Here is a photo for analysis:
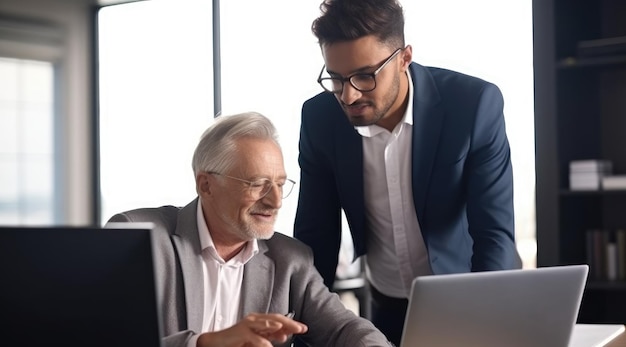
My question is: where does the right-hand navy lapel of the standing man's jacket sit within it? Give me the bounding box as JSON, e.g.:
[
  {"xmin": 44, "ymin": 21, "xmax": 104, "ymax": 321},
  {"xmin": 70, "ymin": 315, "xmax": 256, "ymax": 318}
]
[{"xmin": 410, "ymin": 63, "xmax": 444, "ymax": 220}]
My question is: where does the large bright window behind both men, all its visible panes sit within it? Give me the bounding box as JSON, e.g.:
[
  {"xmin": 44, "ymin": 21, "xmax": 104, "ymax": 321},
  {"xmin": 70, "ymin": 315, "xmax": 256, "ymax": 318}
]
[{"xmin": 99, "ymin": 0, "xmax": 536, "ymax": 267}]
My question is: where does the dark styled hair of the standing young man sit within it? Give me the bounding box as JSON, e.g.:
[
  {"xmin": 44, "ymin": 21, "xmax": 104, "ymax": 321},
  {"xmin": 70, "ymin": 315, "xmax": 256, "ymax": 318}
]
[{"xmin": 311, "ymin": 0, "xmax": 404, "ymax": 48}]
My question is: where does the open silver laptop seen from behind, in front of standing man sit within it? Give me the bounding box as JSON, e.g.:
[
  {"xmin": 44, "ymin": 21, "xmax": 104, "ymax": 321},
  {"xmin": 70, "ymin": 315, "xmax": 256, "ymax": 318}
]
[{"xmin": 400, "ymin": 264, "xmax": 589, "ymax": 347}]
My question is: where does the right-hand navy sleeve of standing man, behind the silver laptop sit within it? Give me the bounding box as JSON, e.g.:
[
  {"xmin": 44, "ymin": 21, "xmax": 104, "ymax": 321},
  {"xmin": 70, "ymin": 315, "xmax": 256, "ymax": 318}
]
[{"xmin": 466, "ymin": 84, "xmax": 521, "ymax": 271}]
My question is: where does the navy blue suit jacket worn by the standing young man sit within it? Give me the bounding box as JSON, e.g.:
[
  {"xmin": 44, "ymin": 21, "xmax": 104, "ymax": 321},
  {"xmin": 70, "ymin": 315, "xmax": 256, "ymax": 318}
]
[{"xmin": 294, "ymin": 63, "xmax": 521, "ymax": 287}]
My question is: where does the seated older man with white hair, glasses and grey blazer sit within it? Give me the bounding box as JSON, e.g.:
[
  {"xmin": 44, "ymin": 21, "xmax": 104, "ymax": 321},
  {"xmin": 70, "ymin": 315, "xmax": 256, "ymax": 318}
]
[{"xmin": 109, "ymin": 113, "xmax": 389, "ymax": 347}]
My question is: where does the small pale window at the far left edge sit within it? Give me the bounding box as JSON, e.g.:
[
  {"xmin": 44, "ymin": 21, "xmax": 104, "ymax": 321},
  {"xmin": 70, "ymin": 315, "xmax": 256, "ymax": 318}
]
[{"xmin": 0, "ymin": 58, "xmax": 56, "ymax": 225}]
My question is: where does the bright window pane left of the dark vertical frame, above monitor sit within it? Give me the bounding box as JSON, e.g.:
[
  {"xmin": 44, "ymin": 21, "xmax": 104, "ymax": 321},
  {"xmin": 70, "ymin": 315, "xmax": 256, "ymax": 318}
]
[{"xmin": 98, "ymin": 0, "xmax": 213, "ymax": 223}]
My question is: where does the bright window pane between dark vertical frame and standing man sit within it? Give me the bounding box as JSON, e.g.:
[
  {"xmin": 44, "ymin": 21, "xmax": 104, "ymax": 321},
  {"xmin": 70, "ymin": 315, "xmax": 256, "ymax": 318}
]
[{"xmin": 220, "ymin": 0, "xmax": 324, "ymax": 235}]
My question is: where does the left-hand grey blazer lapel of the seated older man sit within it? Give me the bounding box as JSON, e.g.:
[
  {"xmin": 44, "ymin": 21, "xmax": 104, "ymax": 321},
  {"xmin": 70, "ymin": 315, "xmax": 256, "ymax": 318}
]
[{"xmin": 172, "ymin": 199, "xmax": 204, "ymax": 331}]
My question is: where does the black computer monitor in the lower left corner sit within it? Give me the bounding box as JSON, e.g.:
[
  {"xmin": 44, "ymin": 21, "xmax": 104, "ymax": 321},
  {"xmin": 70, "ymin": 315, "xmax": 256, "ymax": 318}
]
[{"xmin": 0, "ymin": 224, "xmax": 161, "ymax": 347}]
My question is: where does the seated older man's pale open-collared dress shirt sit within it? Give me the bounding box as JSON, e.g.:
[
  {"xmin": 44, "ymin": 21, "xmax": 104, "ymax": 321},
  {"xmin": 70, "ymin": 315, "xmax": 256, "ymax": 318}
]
[{"xmin": 188, "ymin": 200, "xmax": 259, "ymax": 347}]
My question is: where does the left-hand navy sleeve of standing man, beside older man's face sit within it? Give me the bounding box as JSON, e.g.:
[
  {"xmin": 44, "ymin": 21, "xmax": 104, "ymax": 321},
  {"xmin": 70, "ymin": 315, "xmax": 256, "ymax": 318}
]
[{"xmin": 294, "ymin": 97, "xmax": 341, "ymax": 288}]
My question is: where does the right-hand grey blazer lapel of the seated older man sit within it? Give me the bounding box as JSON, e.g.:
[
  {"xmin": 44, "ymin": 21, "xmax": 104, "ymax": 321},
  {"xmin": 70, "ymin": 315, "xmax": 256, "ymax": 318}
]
[{"xmin": 241, "ymin": 240, "xmax": 275, "ymax": 316}]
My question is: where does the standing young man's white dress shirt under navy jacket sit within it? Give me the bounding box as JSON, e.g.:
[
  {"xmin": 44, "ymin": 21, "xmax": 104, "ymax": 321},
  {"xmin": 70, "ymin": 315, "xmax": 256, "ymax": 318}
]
[{"xmin": 355, "ymin": 73, "xmax": 432, "ymax": 298}]
